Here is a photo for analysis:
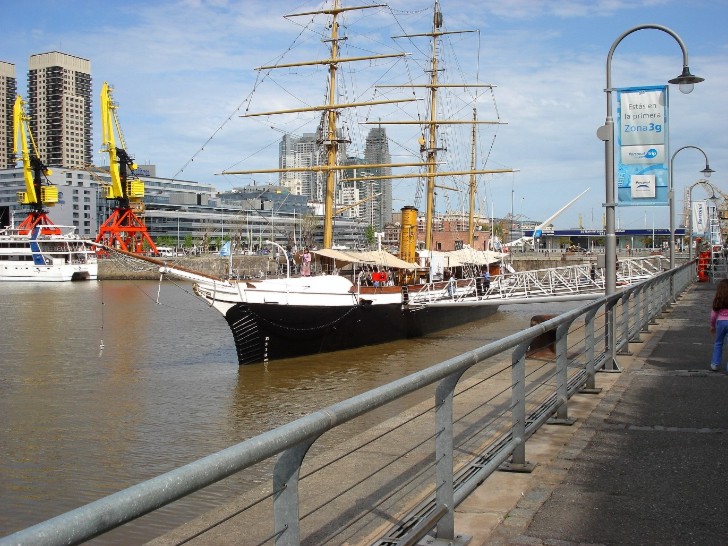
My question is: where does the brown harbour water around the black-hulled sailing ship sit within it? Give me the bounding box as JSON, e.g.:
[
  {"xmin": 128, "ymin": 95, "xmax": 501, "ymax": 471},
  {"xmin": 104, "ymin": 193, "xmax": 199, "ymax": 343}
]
[{"xmin": 0, "ymin": 281, "xmax": 570, "ymax": 544}]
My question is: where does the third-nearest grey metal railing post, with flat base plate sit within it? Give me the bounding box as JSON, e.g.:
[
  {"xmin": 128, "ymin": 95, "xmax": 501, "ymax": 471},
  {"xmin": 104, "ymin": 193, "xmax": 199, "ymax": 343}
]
[{"xmin": 501, "ymin": 339, "xmax": 535, "ymax": 472}]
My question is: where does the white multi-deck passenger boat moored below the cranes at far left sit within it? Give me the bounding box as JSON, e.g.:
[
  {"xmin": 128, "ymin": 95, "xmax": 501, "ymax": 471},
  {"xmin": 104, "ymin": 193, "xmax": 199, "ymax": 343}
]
[{"xmin": 0, "ymin": 224, "xmax": 98, "ymax": 282}]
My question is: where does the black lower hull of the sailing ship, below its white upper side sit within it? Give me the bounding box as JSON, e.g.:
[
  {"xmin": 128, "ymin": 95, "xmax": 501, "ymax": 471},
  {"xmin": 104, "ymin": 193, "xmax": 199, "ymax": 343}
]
[{"xmin": 225, "ymin": 302, "xmax": 498, "ymax": 365}]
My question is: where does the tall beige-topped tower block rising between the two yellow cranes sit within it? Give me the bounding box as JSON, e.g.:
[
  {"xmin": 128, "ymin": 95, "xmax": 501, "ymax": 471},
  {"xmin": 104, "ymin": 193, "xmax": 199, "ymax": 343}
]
[{"xmin": 28, "ymin": 51, "xmax": 93, "ymax": 168}]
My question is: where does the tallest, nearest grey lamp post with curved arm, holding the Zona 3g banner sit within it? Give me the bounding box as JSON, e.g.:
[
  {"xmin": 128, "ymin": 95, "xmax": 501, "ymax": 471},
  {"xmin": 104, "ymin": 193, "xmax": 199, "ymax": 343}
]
[{"xmin": 597, "ymin": 24, "xmax": 704, "ymax": 369}]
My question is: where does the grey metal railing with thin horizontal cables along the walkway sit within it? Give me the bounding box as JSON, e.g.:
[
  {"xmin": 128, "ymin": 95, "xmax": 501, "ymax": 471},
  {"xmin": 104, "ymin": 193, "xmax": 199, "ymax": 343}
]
[{"xmin": 0, "ymin": 262, "xmax": 696, "ymax": 546}]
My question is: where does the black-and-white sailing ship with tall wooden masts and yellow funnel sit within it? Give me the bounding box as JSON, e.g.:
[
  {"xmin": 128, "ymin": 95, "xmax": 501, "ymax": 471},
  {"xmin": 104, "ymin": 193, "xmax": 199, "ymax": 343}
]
[{"xmin": 161, "ymin": 0, "xmax": 512, "ymax": 364}]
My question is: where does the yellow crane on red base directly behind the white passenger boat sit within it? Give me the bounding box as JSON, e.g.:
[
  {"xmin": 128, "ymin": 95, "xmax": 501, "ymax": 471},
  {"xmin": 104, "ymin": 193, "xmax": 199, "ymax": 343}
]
[{"xmin": 13, "ymin": 95, "xmax": 60, "ymax": 233}]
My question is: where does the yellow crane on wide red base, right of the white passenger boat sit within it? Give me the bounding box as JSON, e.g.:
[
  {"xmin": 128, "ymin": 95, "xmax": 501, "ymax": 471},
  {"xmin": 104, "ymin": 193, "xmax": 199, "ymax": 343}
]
[{"xmin": 96, "ymin": 82, "xmax": 157, "ymax": 254}]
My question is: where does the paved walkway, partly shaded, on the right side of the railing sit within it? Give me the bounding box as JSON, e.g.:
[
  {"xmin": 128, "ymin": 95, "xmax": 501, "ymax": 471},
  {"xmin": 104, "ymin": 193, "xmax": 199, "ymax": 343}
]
[{"xmin": 455, "ymin": 283, "xmax": 728, "ymax": 546}]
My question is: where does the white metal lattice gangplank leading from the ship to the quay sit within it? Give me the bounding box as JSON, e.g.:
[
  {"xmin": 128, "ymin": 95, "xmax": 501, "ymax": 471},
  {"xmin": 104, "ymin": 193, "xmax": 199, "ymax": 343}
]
[{"xmin": 408, "ymin": 255, "xmax": 669, "ymax": 307}]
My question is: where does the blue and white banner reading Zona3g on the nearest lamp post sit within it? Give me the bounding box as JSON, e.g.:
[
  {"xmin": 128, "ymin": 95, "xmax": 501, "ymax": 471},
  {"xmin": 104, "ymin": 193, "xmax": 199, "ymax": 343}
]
[{"xmin": 616, "ymin": 86, "xmax": 669, "ymax": 206}]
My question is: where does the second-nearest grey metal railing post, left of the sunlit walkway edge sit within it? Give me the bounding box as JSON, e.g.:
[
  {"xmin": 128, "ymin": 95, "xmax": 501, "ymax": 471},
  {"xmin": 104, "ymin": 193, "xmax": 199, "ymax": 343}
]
[{"xmin": 435, "ymin": 372, "xmax": 464, "ymax": 540}]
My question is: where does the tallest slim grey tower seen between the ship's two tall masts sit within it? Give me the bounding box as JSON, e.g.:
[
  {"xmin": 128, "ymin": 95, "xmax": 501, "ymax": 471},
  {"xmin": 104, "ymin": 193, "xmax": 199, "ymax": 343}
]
[{"xmin": 359, "ymin": 127, "xmax": 392, "ymax": 231}]
